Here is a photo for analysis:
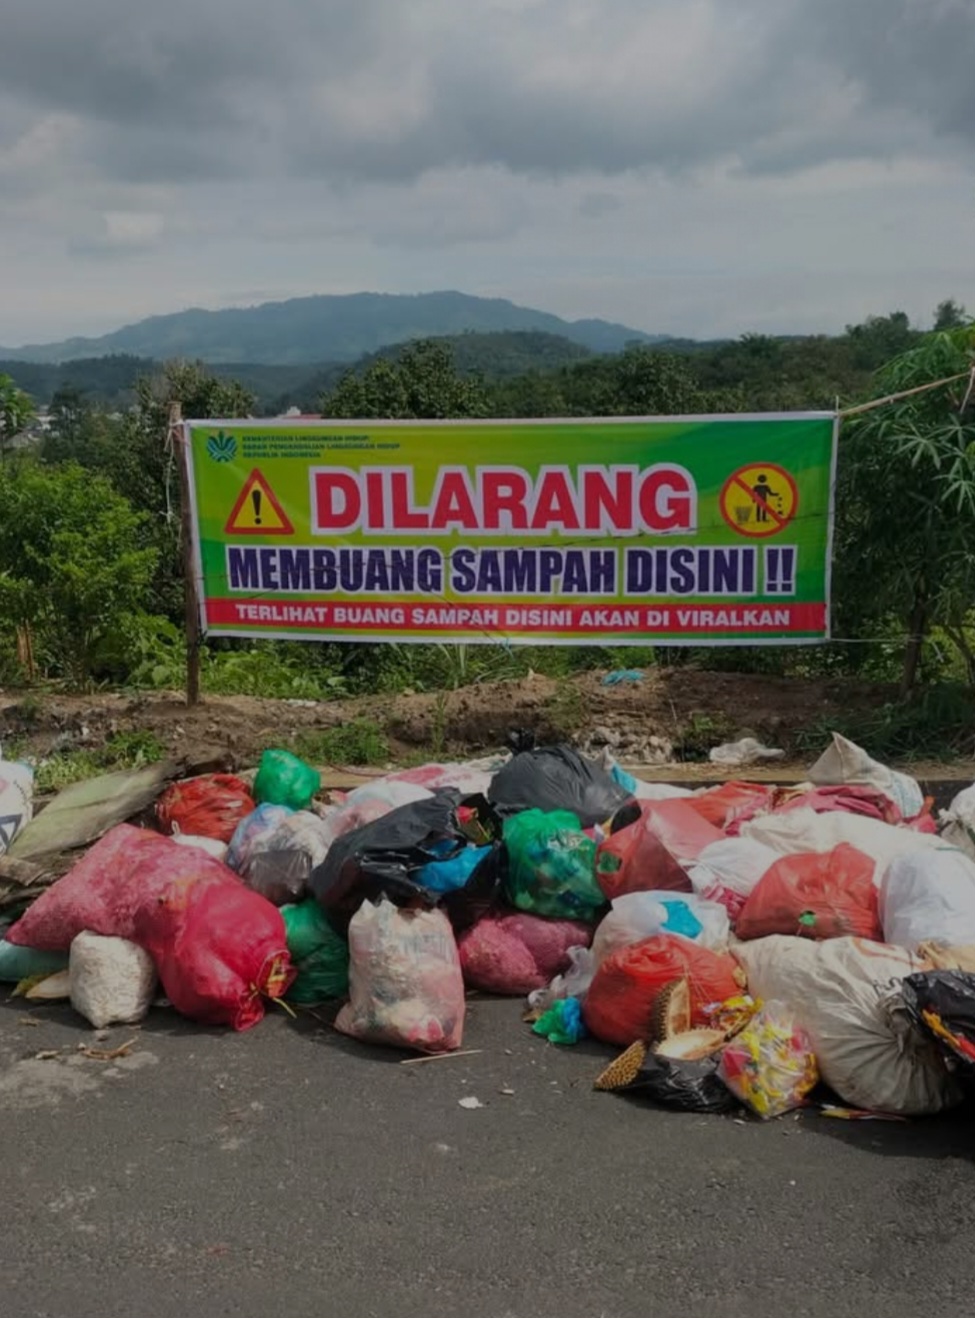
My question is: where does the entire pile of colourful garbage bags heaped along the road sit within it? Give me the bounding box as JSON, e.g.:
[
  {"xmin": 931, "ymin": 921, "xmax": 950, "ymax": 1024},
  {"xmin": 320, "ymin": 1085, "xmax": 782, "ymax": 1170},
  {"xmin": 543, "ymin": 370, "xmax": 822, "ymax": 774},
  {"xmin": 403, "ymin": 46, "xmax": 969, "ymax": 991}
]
[{"xmin": 0, "ymin": 735, "xmax": 975, "ymax": 1118}]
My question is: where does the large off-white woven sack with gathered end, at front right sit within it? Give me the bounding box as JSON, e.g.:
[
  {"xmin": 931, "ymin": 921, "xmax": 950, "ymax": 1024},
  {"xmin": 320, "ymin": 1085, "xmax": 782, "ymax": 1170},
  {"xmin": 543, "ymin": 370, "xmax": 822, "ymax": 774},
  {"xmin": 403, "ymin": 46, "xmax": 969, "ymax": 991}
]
[{"xmin": 734, "ymin": 934, "xmax": 962, "ymax": 1116}]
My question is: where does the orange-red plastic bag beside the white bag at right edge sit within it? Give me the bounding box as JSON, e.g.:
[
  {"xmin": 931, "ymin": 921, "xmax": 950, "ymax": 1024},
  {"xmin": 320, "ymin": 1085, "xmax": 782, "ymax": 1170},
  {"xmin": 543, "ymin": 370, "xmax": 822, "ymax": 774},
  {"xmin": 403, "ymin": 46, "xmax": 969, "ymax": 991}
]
[{"xmin": 735, "ymin": 842, "xmax": 883, "ymax": 942}]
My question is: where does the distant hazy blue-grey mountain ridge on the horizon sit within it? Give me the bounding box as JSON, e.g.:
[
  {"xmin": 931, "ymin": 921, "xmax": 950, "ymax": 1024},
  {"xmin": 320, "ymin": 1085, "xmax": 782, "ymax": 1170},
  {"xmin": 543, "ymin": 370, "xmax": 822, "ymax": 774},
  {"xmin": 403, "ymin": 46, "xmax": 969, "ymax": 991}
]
[{"xmin": 0, "ymin": 293, "xmax": 668, "ymax": 366}]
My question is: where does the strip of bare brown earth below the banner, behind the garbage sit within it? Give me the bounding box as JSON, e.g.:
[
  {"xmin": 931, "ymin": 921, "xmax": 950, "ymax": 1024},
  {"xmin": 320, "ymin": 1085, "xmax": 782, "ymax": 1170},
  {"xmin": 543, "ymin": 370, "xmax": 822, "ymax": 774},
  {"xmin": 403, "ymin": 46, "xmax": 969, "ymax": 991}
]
[{"xmin": 0, "ymin": 668, "xmax": 891, "ymax": 767}]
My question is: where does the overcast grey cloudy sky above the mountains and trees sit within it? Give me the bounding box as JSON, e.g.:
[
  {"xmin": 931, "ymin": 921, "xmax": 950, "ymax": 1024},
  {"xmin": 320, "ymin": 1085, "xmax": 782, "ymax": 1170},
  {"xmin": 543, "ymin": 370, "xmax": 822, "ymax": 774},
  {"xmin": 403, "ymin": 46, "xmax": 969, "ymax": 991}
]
[{"xmin": 0, "ymin": 0, "xmax": 975, "ymax": 345}]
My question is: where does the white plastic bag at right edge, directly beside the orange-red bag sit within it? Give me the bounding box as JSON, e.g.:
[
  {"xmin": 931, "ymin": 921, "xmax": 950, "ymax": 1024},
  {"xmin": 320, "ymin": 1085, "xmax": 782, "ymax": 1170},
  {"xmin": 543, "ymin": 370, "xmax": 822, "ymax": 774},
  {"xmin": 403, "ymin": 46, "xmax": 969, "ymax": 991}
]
[{"xmin": 880, "ymin": 851, "xmax": 975, "ymax": 952}]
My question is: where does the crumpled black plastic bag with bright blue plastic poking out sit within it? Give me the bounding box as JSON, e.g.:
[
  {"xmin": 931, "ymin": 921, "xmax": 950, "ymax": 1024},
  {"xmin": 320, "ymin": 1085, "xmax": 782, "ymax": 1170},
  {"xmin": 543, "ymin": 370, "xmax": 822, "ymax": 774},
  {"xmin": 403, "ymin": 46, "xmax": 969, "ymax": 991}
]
[{"xmin": 310, "ymin": 789, "xmax": 507, "ymax": 933}]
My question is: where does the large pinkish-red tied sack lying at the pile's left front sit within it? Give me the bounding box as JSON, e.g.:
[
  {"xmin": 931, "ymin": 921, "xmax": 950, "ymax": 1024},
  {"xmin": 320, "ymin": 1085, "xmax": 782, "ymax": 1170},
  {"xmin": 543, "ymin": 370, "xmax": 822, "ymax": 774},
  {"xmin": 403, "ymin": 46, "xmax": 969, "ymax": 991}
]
[{"xmin": 7, "ymin": 824, "xmax": 291, "ymax": 1029}]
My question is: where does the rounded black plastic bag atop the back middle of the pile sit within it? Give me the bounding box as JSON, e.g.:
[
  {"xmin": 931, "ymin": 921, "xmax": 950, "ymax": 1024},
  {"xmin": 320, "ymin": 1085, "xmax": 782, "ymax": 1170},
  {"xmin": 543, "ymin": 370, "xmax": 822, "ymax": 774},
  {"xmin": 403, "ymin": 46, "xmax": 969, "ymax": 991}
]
[{"xmin": 488, "ymin": 746, "xmax": 631, "ymax": 828}]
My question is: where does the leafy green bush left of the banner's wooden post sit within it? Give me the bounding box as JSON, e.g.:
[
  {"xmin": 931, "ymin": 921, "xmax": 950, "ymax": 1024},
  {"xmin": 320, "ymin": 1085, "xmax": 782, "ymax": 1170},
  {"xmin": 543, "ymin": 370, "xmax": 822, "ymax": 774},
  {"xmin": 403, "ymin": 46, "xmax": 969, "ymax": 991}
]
[{"xmin": 0, "ymin": 461, "xmax": 158, "ymax": 685}]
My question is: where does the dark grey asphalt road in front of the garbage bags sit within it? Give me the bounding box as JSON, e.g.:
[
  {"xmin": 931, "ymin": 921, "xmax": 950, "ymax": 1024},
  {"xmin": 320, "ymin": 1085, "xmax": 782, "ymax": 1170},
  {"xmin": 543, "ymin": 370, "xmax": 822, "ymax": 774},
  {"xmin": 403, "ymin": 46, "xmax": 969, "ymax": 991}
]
[{"xmin": 0, "ymin": 1000, "xmax": 975, "ymax": 1318}]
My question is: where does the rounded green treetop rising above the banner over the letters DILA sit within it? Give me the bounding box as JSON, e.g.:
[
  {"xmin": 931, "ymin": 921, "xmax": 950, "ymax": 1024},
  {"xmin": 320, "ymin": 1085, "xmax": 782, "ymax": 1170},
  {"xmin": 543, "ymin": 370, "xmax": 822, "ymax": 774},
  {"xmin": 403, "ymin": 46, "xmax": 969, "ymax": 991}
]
[{"xmin": 320, "ymin": 339, "xmax": 490, "ymax": 420}]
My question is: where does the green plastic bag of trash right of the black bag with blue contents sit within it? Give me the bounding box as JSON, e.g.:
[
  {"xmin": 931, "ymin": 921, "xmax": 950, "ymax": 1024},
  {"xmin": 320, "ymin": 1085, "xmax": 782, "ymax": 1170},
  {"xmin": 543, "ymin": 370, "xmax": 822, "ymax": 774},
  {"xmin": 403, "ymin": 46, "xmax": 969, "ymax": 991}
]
[{"xmin": 505, "ymin": 811, "xmax": 606, "ymax": 920}]
